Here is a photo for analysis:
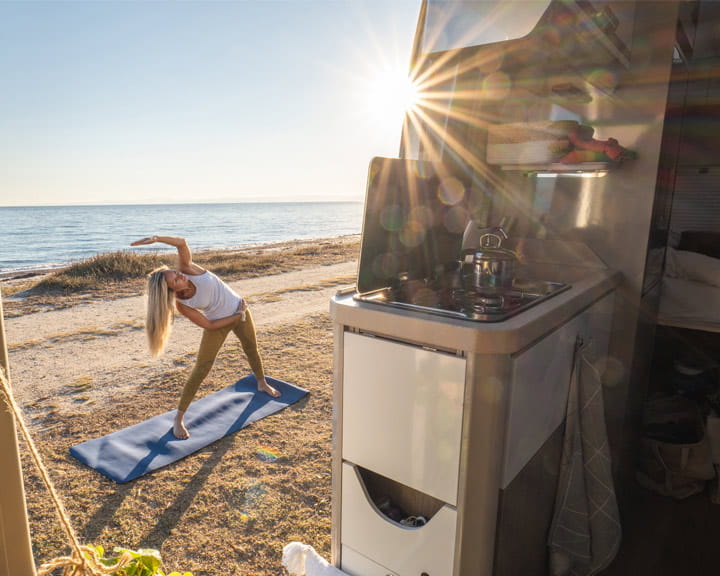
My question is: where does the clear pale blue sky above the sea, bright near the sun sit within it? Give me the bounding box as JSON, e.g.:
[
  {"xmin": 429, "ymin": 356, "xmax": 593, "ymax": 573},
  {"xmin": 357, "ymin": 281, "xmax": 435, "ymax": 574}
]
[{"xmin": 0, "ymin": 0, "xmax": 420, "ymax": 205}]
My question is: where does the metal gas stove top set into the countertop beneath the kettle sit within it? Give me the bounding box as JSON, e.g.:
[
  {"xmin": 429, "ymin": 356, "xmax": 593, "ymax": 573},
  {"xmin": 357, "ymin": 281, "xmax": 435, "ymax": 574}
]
[{"xmin": 354, "ymin": 280, "xmax": 570, "ymax": 322}]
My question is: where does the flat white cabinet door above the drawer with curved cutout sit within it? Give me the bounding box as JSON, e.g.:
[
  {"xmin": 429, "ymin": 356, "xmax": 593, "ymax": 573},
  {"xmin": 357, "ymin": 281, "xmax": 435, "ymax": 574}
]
[{"xmin": 342, "ymin": 333, "xmax": 465, "ymax": 505}]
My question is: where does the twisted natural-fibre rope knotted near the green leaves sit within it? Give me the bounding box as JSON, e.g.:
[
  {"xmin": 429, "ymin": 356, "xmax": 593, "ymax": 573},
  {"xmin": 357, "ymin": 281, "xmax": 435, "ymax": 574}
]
[{"xmin": 0, "ymin": 367, "xmax": 133, "ymax": 576}]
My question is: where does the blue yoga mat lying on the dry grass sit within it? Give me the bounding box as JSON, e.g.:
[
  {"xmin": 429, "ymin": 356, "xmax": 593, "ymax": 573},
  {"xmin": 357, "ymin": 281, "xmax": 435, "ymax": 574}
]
[{"xmin": 70, "ymin": 375, "xmax": 307, "ymax": 483}]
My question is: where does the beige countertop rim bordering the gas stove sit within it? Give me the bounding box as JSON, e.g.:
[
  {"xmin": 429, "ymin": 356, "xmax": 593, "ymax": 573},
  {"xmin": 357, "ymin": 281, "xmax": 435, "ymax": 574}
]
[{"xmin": 330, "ymin": 267, "xmax": 621, "ymax": 354}]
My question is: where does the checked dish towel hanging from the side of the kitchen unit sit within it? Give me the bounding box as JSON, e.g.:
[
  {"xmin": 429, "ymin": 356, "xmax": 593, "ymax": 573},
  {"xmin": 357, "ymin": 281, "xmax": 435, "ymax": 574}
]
[{"xmin": 548, "ymin": 339, "xmax": 622, "ymax": 576}]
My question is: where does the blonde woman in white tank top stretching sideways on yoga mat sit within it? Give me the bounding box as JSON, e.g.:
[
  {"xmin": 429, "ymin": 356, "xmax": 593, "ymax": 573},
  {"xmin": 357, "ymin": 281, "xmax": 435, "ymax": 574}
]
[{"xmin": 131, "ymin": 236, "xmax": 280, "ymax": 440}]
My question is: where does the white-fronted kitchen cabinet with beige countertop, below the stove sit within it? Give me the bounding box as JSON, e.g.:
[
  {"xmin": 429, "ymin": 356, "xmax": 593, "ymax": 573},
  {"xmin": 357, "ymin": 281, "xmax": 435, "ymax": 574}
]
[{"xmin": 331, "ymin": 249, "xmax": 619, "ymax": 576}]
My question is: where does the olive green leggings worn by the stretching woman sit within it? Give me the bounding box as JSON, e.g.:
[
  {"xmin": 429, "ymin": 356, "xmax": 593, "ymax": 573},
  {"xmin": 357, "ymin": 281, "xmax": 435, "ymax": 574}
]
[{"xmin": 178, "ymin": 310, "xmax": 265, "ymax": 412}]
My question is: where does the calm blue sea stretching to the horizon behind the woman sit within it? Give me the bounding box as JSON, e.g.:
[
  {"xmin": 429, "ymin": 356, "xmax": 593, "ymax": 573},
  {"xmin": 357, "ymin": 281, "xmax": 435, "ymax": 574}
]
[{"xmin": 0, "ymin": 202, "xmax": 363, "ymax": 276}]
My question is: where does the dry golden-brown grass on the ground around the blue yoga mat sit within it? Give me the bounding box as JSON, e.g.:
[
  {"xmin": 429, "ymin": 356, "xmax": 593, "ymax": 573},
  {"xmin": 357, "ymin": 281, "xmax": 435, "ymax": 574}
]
[{"xmin": 9, "ymin": 242, "xmax": 358, "ymax": 576}]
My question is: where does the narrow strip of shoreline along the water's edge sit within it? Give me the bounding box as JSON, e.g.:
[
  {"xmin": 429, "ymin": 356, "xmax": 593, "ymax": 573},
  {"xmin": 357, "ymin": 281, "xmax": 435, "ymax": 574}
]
[{"xmin": 0, "ymin": 232, "xmax": 361, "ymax": 286}]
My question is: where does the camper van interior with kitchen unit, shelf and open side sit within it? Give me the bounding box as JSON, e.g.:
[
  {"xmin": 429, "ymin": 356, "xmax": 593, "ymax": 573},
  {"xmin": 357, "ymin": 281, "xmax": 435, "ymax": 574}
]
[{"xmin": 331, "ymin": 0, "xmax": 720, "ymax": 576}]
